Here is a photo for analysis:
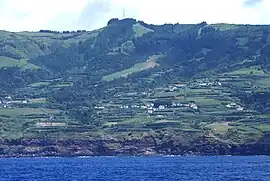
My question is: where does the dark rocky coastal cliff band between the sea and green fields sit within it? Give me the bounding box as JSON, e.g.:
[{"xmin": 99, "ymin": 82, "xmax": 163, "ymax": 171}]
[{"xmin": 0, "ymin": 136, "xmax": 270, "ymax": 157}]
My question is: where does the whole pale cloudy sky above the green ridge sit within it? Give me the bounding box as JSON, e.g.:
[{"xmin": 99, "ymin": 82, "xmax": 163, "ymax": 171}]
[{"xmin": 0, "ymin": 0, "xmax": 270, "ymax": 32}]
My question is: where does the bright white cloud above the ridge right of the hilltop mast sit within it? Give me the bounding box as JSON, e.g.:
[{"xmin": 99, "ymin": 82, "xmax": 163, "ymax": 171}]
[{"xmin": 115, "ymin": 0, "xmax": 270, "ymax": 24}]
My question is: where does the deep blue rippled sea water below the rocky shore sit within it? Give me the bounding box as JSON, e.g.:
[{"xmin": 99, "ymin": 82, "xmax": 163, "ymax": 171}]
[{"xmin": 0, "ymin": 156, "xmax": 270, "ymax": 181}]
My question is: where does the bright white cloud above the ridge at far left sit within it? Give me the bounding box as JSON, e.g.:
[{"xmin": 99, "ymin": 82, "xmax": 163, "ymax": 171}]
[{"xmin": 0, "ymin": 0, "xmax": 88, "ymax": 31}]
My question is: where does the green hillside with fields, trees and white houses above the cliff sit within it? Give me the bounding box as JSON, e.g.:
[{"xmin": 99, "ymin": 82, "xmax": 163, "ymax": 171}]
[{"xmin": 0, "ymin": 19, "xmax": 270, "ymax": 156}]
